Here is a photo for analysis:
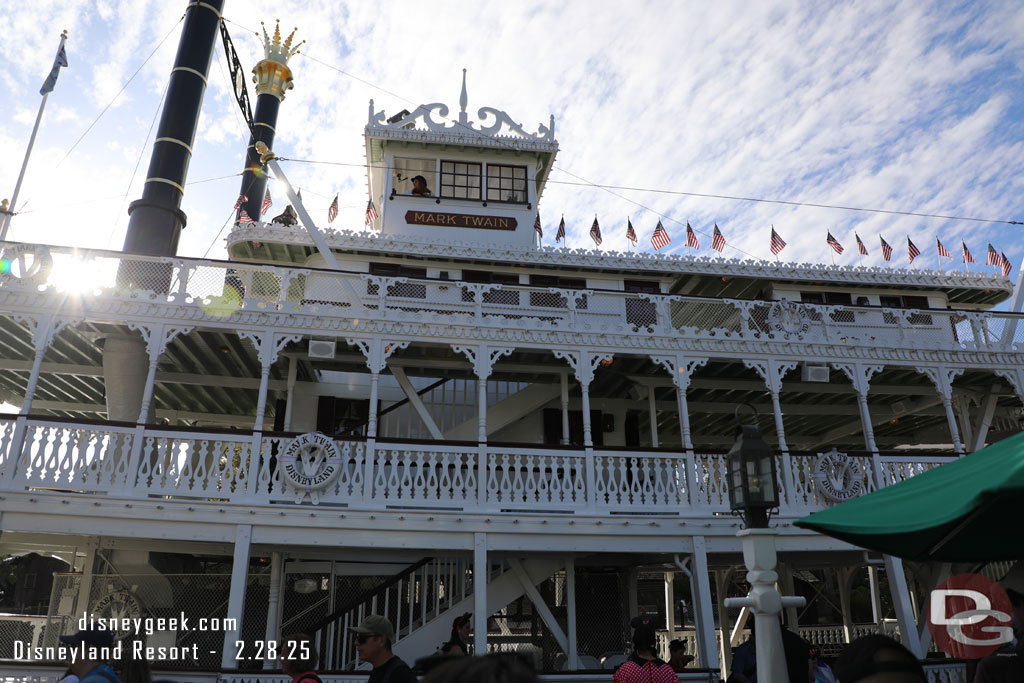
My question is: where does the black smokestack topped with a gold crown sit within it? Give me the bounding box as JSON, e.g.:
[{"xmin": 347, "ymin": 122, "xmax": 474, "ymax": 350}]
[{"xmin": 239, "ymin": 20, "xmax": 305, "ymax": 220}]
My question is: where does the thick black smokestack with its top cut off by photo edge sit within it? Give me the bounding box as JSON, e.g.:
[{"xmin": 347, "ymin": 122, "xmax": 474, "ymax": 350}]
[{"xmin": 121, "ymin": 0, "xmax": 224, "ymax": 259}]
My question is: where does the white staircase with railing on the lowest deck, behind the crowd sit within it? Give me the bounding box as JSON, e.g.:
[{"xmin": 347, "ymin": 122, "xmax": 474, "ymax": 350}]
[{"xmin": 309, "ymin": 557, "xmax": 561, "ymax": 671}]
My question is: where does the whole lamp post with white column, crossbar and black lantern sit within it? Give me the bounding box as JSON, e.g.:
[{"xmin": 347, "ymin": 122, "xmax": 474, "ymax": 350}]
[{"xmin": 725, "ymin": 408, "xmax": 806, "ymax": 683}]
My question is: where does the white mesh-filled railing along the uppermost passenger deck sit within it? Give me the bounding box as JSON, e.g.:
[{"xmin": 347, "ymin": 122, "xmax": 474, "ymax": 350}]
[{"xmin": 0, "ymin": 243, "xmax": 1024, "ymax": 351}]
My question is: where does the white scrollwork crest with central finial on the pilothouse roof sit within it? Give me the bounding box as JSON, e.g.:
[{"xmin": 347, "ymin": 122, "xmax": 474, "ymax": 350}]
[{"xmin": 367, "ymin": 69, "xmax": 558, "ymax": 146}]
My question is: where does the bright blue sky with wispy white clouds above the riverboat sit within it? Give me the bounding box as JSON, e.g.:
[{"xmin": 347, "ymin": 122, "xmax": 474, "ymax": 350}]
[{"xmin": 0, "ymin": 0, "xmax": 1024, "ymax": 272}]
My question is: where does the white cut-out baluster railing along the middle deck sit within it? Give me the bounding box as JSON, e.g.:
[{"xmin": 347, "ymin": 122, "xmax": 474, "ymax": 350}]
[{"xmin": 0, "ymin": 416, "xmax": 951, "ymax": 515}]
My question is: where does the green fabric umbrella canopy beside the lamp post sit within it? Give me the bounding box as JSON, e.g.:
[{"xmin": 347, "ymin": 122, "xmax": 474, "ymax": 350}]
[{"xmin": 795, "ymin": 433, "xmax": 1024, "ymax": 562}]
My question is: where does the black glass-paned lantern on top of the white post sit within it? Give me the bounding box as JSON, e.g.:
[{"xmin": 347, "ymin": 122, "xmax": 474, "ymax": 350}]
[{"xmin": 727, "ymin": 408, "xmax": 778, "ymax": 528}]
